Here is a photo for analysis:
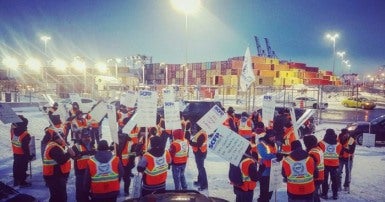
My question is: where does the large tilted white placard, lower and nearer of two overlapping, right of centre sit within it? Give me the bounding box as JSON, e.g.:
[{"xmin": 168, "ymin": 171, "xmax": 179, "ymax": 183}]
[{"xmin": 208, "ymin": 125, "xmax": 250, "ymax": 166}]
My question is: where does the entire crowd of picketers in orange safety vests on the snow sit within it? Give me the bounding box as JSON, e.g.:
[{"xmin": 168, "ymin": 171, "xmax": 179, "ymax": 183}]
[{"xmin": 11, "ymin": 102, "xmax": 356, "ymax": 202}]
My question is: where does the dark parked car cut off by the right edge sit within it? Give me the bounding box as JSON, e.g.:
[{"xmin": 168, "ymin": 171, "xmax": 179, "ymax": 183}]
[{"xmin": 346, "ymin": 115, "xmax": 385, "ymax": 145}]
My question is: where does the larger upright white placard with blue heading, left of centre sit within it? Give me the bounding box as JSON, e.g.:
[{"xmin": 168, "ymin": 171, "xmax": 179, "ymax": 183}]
[{"xmin": 137, "ymin": 90, "xmax": 158, "ymax": 127}]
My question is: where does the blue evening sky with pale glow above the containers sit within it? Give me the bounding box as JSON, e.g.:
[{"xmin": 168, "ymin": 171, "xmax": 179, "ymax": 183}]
[{"xmin": 0, "ymin": 0, "xmax": 385, "ymax": 74}]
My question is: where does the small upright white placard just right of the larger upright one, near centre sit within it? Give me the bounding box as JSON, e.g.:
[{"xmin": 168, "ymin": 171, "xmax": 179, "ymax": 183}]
[{"xmin": 164, "ymin": 102, "xmax": 182, "ymax": 130}]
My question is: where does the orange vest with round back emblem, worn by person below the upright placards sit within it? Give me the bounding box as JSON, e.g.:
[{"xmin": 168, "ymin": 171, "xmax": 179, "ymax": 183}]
[{"xmin": 143, "ymin": 150, "xmax": 171, "ymax": 185}]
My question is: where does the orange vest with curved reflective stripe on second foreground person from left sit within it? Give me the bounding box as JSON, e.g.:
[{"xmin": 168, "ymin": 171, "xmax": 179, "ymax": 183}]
[{"xmin": 43, "ymin": 141, "xmax": 71, "ymax": 176}]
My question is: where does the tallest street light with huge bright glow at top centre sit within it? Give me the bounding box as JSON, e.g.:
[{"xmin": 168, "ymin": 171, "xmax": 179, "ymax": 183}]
[{"xmin": 170, "ymin": 0, "xmax": 201, "ymax": 98}]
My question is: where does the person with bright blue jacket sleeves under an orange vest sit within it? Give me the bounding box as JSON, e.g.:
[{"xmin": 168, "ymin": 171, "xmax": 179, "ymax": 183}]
[{"xmin": 257, "ymin": 129, "xmax": 283, "ymax": 202}]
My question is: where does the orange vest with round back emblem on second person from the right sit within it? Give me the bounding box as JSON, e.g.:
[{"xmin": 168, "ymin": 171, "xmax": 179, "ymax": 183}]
[{"xmin": 319, "ymin": 141, "xmax": 342, "ymax": 166}]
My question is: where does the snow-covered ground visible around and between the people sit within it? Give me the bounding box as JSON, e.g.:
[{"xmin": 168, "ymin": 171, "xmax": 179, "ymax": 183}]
[{"xmin": 0, "ymin": 105, "xmax": 385, "ymax": 202}]
